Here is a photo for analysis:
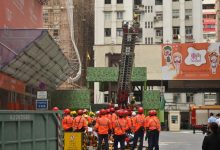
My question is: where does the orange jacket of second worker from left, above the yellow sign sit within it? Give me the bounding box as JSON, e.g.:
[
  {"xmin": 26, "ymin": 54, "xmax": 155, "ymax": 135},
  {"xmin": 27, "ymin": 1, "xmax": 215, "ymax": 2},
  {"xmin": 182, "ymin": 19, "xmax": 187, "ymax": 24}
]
[{"xmin": 73, "ymin": 116, "xmax": 88, "ymax": 130}]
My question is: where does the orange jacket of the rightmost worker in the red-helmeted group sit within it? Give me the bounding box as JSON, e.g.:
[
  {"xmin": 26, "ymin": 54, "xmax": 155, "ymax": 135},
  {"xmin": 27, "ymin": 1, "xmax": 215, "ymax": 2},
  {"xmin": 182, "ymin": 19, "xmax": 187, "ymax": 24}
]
[{"xmin": 146, "ymin": 116, "xmax": 161, "ymax": 131}]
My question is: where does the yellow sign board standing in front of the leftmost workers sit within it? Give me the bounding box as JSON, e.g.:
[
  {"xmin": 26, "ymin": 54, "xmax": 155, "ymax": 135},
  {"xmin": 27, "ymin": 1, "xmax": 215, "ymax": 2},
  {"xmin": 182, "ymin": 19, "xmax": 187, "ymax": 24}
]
[{"xmin": 64, "ymin": 132, "xmax": 82, "ymax": 150}]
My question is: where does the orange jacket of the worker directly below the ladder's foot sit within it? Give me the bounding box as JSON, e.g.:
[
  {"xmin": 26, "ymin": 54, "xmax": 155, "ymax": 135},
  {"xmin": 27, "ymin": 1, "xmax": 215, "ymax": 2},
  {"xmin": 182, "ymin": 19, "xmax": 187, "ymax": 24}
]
[{"xmin": 112, "ymin": 118, "xmax": 128, "ymax": 135}]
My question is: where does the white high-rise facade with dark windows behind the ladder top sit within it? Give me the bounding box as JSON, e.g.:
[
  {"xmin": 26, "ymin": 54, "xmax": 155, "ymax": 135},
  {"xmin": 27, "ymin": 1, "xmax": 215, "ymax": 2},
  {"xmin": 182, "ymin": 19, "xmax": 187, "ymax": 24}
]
[{"xmin": 95, "ymin": 0, "xmax": 203, "ymax": 45}]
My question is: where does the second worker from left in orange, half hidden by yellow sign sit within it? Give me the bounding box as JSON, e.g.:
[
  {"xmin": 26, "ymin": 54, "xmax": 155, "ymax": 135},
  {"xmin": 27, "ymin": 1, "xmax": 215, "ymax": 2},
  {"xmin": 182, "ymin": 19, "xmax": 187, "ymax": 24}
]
[{"xmin": 73, "ymin": 109, "xmax": 88, "ymax": 132}]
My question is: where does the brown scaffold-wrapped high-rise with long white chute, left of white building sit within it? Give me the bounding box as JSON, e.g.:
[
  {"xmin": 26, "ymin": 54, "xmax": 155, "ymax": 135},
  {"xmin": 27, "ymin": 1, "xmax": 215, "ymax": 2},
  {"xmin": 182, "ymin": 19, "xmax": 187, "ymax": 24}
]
[{"xmin": 43, "ymin": 0, "xmax": 94, "ymax": 89}]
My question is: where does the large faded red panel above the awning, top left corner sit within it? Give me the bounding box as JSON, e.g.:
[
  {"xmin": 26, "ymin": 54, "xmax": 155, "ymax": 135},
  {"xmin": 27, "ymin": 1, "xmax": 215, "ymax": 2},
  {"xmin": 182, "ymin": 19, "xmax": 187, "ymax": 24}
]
[{"xmin": 0, "ymin": 0, "xmax": 43, "ymax": 29}]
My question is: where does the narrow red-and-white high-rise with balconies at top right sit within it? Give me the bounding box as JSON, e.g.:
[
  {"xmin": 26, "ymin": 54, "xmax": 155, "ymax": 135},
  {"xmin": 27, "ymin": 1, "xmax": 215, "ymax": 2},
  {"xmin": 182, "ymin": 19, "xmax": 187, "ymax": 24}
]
[{"xmin": 202, "ymin": 0, "xmax": 216, "ymax": 42}]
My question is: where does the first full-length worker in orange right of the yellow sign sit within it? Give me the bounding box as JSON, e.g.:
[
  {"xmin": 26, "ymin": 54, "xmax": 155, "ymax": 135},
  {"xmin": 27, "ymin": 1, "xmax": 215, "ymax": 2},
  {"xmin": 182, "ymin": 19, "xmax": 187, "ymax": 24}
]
[{"xmin": 94, "ymin": 109, "xmax": 112, "ymax": 150}]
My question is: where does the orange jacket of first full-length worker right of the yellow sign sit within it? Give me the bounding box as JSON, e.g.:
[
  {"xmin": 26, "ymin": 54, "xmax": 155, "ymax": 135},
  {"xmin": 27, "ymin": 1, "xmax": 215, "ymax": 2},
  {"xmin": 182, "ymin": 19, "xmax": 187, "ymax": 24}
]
[{"xmin": 95, "ymin": 116, "xmax": 112, "ymax": 134}]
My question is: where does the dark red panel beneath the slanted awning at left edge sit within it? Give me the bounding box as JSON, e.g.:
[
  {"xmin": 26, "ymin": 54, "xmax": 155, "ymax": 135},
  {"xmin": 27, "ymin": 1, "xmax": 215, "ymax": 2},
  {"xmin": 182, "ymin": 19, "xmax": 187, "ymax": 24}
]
[{"xmin": 0, "ymin": 73, "xmax": 25, "ymax": 94}]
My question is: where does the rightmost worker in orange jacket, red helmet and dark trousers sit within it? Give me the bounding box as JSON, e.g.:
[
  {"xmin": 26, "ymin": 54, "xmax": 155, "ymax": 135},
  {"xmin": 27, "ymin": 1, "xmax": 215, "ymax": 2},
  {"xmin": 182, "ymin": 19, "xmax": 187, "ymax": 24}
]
[{"xmin": 146, "ymin": 110, "xmax": 161, "ymax": 150}]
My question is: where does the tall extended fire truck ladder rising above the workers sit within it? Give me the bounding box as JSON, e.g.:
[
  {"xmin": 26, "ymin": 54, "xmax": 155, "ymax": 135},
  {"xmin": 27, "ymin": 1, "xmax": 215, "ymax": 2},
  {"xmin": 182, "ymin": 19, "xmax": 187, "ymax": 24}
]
[{"xmin": 118, "ymin": 24, "xmax": 137, "ymax": 108}]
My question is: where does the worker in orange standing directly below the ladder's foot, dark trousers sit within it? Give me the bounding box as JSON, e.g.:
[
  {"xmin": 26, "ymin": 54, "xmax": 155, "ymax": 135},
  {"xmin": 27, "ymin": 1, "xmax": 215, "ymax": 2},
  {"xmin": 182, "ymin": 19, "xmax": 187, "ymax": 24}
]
[{"xmin": 112, "ymin": 110, "xmax": 128, "ymax": 150}]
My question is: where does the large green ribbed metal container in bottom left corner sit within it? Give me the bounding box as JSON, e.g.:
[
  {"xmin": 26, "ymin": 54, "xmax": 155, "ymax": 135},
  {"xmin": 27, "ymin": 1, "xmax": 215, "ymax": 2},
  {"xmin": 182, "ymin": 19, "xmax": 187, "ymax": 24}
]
[{"xmin": 0, "ymin": 111, "xmax": 58, "ymax": 150}]
